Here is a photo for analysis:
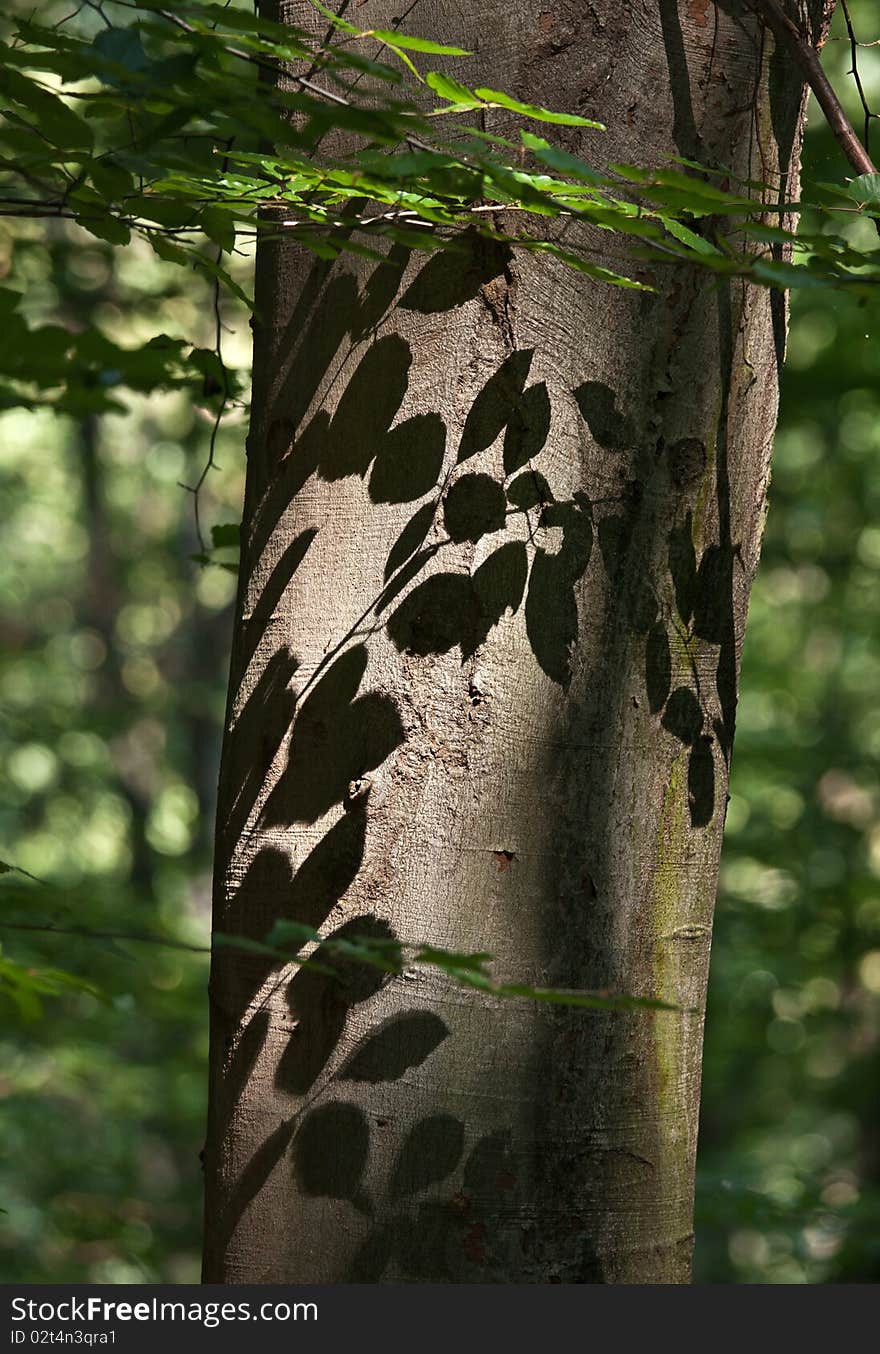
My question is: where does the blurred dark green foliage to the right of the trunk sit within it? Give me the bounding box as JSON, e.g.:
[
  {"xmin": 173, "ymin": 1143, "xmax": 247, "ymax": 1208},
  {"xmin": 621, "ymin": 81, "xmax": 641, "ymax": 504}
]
[{"xmin": 697, "ymin": 0, "xmax": 880, "ymax": 1284}]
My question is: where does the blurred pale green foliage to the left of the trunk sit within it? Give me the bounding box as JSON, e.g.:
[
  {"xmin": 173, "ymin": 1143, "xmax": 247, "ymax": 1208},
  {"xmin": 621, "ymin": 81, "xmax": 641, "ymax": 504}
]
[{"xmin": 0, "ymin": 34, "xmax": 250, "ymax": 1282}]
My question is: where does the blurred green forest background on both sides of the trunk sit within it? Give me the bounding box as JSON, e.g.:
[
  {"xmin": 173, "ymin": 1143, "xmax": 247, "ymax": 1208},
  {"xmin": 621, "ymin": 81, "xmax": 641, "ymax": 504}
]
[{"xmin": 0, "ymin": 0, "xmax": 880, "ymax": 1284}]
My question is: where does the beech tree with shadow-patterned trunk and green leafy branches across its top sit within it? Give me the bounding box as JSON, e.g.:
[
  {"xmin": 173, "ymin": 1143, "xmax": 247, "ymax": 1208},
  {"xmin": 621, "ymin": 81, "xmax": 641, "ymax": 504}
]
[{"xmin": 1, "ymin": 0, "xmax": 880, "ymax": 1284}]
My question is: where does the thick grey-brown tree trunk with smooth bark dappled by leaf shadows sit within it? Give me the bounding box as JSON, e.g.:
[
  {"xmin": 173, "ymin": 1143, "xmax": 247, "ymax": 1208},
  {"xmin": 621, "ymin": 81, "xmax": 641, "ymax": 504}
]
[{"xmin": 204, "ymin": 0, "xmax": 822, "ymax": 1284}]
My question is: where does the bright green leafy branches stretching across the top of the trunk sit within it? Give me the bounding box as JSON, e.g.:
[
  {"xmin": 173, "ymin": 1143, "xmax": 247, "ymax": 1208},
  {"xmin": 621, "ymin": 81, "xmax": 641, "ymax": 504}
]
[{"xmin": 0, "ymin": 0, "xmax": 880, "ymax": 298}]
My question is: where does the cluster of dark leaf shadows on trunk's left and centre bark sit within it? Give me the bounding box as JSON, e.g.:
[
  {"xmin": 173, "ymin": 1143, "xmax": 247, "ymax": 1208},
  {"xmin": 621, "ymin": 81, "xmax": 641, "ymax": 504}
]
[{"xmin": 211, "ymin": 246, "xmax": 671, "ymax": 1282}]
